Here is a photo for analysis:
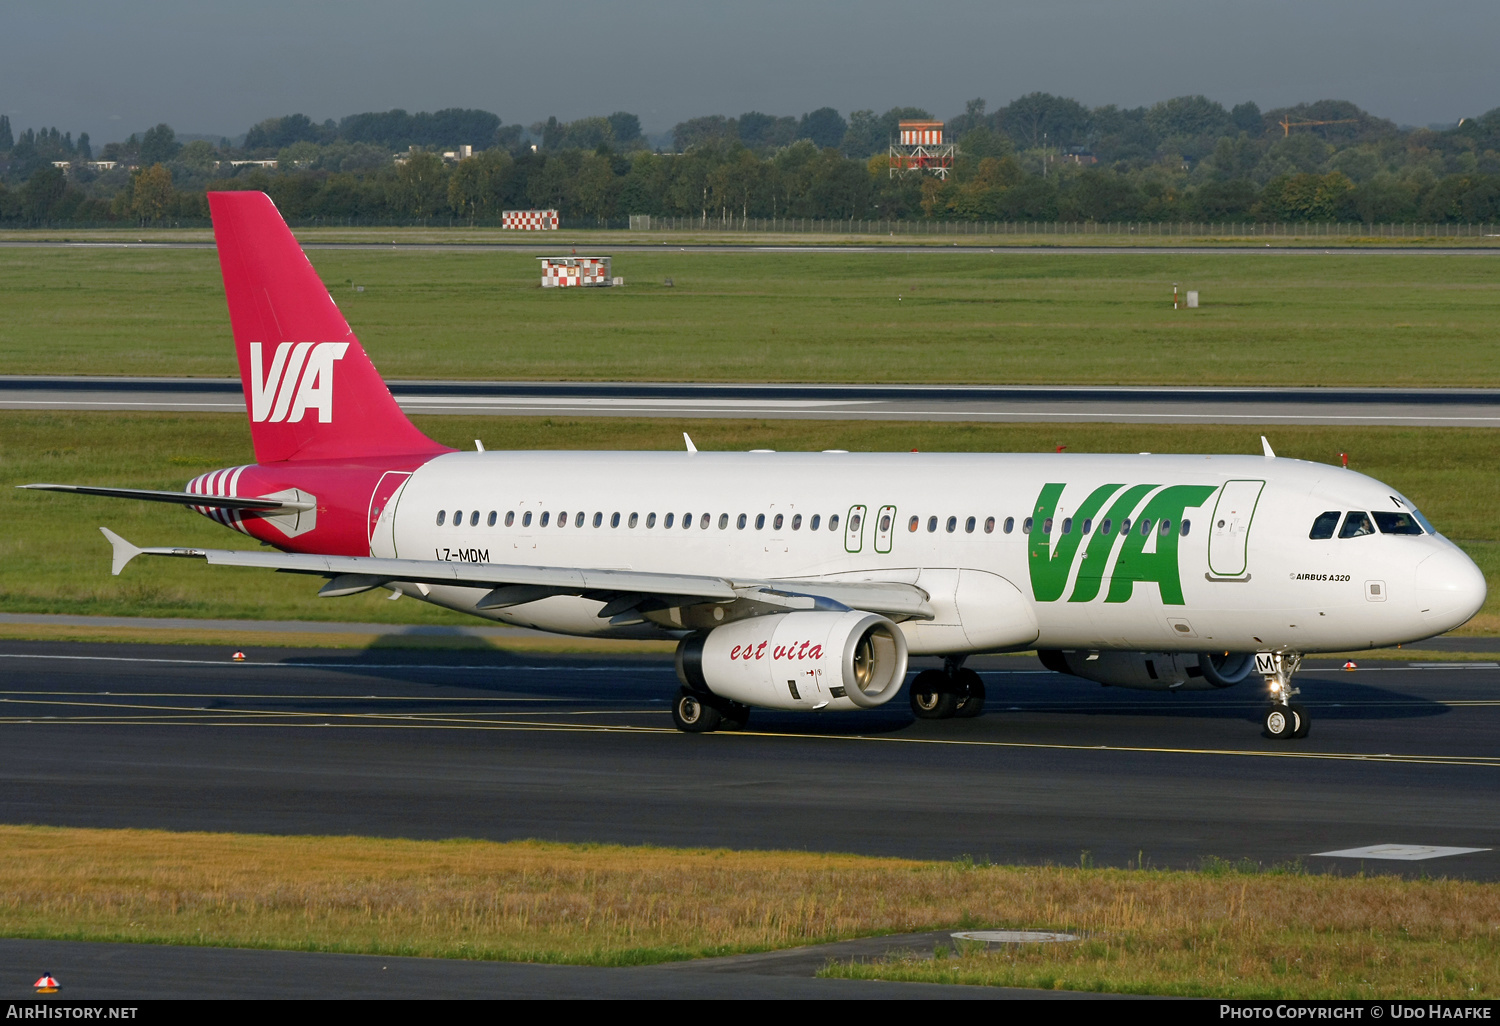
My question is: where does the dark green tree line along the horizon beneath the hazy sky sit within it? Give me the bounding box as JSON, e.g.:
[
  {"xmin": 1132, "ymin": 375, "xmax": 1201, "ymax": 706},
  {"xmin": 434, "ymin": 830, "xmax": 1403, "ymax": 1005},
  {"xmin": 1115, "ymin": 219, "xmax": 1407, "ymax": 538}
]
[{"xmin": 0, "ymin": 93, "xmax": 1500, "ymax": 225}]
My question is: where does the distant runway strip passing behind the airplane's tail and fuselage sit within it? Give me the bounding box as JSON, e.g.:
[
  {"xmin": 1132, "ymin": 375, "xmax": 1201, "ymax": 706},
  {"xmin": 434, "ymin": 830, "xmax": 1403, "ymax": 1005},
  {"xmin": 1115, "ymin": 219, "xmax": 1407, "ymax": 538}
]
[{"xmin": 0, "ymin": 375, "xmax": 1500, "ymax": 428}]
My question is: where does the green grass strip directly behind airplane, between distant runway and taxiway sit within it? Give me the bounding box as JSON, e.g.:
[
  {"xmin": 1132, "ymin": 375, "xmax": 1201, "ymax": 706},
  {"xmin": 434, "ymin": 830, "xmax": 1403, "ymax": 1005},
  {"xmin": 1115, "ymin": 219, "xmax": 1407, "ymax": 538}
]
[{"xmin": 0, "ymin": 411, "xmax": 1500, "ymax": 633}]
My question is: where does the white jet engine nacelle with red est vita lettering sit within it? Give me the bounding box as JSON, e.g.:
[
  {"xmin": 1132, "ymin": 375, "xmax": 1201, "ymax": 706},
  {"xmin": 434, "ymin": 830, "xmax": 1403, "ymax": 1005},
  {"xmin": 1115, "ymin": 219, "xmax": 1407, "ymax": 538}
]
[{"xmin": 677, "ymin": 609, "xmax": 906, "ymax": 710}]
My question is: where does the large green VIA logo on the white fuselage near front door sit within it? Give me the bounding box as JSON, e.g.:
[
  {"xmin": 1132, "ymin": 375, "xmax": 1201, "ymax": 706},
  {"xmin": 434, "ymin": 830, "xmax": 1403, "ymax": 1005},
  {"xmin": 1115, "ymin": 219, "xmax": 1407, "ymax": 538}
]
[{"xmin": 1026, "ymin": 485, "xmax": 1218, "ymax": 606}]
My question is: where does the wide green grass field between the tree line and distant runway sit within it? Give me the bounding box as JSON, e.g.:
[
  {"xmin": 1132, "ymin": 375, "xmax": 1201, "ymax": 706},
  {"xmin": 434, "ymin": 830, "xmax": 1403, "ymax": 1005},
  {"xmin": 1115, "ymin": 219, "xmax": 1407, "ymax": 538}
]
[{"xmin": 0, "ymin": 243, "xmax": 1500, "ymax": 386}]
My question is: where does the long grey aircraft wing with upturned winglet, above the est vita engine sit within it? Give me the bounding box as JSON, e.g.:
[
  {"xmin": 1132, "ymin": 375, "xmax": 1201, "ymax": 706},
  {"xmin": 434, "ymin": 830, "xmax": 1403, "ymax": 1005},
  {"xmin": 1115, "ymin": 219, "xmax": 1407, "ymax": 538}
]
[{"xmin": 99, "ymin": 528, "xmax": 933, "ymax": 620}]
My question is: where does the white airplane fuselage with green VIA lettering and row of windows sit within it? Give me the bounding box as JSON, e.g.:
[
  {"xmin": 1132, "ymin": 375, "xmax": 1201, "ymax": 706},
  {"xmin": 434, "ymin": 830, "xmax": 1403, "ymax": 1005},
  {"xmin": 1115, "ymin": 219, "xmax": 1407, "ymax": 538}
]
[{"xmin": 371, "ymin": 452, "xmax": 1485, "ymax": 654}]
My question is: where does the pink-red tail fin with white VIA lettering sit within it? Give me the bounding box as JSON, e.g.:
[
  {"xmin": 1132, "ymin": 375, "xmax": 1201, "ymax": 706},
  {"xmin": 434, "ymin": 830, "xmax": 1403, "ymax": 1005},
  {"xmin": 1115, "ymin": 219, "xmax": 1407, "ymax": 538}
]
[{"xmin": 209, "ymin": 192, "xmax": 447, "ymax": 464}]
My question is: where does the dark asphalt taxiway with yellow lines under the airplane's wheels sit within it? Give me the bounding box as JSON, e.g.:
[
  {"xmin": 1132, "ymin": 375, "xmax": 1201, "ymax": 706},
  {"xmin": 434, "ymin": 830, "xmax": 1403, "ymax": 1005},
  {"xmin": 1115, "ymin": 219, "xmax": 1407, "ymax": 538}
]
[{"xmin": 0, "ymin": 642, "xmax": 1500, "ymax": 881}]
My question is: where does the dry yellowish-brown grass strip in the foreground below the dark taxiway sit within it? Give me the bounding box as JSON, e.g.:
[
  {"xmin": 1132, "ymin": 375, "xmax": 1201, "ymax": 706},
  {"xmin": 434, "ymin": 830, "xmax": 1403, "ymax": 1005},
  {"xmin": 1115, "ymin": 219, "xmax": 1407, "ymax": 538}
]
[{"xmin": 0, "ymin": 827, "xmax": 1500, "ymax": 999}]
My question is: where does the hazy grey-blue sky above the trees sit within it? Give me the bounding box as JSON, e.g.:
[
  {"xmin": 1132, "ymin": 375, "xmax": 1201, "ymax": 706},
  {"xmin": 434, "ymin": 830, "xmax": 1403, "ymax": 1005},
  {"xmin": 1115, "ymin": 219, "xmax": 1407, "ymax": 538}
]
[{"xmin": 0, "ymin": 0, "xmax": 1500, "ymax": 146}]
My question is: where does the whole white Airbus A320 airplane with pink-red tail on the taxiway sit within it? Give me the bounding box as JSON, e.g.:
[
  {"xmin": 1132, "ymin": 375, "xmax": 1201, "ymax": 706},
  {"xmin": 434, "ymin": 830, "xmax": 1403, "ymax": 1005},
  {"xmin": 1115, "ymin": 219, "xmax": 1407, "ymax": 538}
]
[{"xmin": 26, "ymin": 192, "xmax": 1485, "ymax": 738}]
